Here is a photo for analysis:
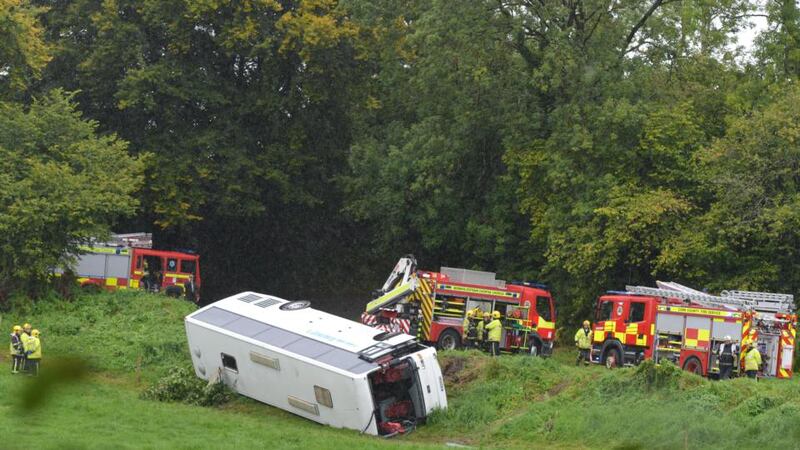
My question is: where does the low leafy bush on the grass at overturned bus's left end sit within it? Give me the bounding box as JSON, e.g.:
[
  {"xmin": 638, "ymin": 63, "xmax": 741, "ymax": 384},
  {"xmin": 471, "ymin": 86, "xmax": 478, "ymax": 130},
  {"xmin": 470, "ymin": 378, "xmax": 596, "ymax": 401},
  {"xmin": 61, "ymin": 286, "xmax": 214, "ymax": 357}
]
[{"xmin": 141, "ymin": 367, "xmax": 232, "ymax": 406}]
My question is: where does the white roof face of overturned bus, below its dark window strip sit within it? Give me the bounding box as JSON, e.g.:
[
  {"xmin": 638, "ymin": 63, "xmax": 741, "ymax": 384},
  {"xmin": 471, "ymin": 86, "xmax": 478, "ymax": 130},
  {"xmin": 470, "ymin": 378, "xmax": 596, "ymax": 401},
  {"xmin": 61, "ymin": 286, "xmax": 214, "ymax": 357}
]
[{"xmin": 186, "ymin": 321, "xmax": 377, "ymax": 434}]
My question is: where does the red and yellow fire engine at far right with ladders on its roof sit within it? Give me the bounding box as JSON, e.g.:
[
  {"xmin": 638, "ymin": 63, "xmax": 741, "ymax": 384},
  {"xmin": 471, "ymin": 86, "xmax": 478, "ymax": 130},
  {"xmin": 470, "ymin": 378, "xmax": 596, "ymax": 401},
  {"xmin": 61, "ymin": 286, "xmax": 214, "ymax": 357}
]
[{"xmin": 591, "ymin": 281, "xmax": 797, "ymax": 378}]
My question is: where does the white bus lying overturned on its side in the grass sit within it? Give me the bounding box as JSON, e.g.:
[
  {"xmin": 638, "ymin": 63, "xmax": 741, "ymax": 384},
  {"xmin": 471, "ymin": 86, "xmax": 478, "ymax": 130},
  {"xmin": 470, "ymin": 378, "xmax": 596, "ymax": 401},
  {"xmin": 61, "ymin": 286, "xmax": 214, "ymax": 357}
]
[{"xmin": 186, "ymin": 292, "xmax": 447, "ymax": 436}]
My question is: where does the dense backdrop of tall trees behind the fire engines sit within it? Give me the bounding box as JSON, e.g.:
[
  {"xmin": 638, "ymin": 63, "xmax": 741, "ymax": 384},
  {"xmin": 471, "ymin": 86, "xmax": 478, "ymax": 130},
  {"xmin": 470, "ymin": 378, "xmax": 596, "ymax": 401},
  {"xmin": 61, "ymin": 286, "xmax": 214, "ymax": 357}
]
[{"xmin": 0, "ymin": 0, "xmax": 800, "ymax": 322}]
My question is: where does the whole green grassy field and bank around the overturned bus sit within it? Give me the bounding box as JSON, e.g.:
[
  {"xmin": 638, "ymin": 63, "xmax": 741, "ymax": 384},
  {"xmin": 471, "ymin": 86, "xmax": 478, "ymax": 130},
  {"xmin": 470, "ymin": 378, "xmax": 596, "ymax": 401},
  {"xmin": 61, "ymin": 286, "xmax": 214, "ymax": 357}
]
[{"xmin": 0, "ymin": 292, "xmax": 800, "ymax": 449}]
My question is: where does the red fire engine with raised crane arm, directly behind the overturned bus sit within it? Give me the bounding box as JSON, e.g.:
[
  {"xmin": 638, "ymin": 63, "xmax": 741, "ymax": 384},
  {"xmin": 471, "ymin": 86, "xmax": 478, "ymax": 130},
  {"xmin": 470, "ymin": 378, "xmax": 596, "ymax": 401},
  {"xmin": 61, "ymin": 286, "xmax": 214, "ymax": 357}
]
[{"xmin": 361, "ymin": 256, "xmax": 555, "ymax": 355}]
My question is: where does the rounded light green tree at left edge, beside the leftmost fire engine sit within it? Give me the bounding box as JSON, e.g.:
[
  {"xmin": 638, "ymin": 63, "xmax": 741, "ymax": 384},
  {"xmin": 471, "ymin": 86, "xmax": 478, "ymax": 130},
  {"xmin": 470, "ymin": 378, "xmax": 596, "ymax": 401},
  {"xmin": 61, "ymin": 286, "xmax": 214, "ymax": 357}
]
[{"xmin": 0, "ymin": 90, "xmax": 144, "ymax": 299}]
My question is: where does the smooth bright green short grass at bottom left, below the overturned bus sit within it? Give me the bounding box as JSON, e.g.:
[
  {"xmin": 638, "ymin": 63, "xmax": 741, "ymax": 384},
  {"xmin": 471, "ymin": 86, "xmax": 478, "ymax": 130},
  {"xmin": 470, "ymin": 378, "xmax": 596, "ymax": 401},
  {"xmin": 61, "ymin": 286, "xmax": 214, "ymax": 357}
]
[{"xmin": 0, "ymin": 372, "xmax": 438, "ymax": 450}]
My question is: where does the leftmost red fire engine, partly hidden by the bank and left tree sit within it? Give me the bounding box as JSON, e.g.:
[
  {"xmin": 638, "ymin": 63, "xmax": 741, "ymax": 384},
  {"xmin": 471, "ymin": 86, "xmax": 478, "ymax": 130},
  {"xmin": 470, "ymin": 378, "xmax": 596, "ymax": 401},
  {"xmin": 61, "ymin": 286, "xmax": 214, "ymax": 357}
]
[{"xmin": 67, "ymin": 233, "xmax": 201, "ymax": 301}]
